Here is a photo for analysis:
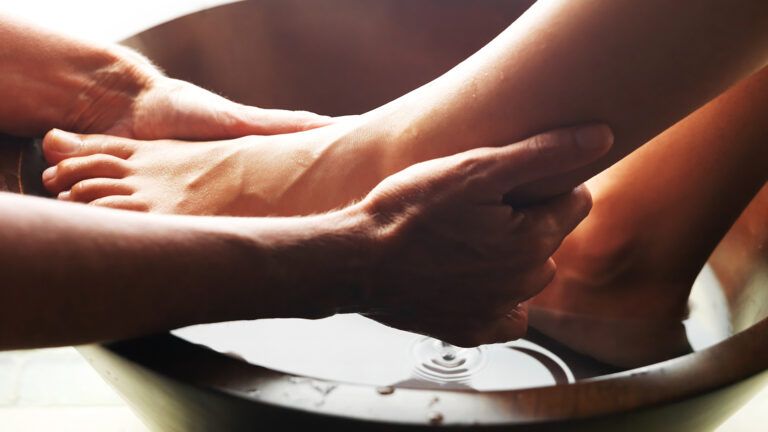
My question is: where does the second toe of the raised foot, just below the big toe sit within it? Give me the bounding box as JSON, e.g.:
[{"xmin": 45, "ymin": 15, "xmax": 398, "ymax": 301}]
[{"xmin": 43, "ymin": 154, "xmax": 129, "ymax": 194}]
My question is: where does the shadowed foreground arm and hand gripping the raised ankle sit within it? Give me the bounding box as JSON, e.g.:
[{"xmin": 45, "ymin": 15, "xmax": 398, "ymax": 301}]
[{"xmin": 0, "ymin": 125, "xmax": 612, "ymax": 349}]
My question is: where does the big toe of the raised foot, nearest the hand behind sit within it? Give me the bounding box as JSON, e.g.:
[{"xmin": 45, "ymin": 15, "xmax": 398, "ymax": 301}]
[{"xmin": 43, "ymin": 129, "xmax": 136, "ymax": 164}]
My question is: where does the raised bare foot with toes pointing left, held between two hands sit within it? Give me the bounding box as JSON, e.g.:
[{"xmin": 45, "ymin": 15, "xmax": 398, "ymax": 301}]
[{"xmin": 43, "ymin": 119, "xmax": 384, "ymax": 216}]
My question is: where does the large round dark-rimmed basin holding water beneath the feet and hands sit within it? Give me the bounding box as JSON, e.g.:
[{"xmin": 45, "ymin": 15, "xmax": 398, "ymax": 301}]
[{"xmin": 0, "ymin": 0, "xmax": 768, "ymax": 431}]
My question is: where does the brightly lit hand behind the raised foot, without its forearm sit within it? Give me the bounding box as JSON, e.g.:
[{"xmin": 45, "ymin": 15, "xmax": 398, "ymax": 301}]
[{"xmin": 74, "ymin": 50, "xmax": 332, "ymax": 140}]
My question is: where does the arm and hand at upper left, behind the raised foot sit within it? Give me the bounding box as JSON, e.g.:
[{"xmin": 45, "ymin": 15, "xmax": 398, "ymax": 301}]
[{"xmin": 0, "ymin": 14, "xmax": 330, "ymax": 140}]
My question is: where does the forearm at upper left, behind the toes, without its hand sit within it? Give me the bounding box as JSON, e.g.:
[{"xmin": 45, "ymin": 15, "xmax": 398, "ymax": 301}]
[{"xmin": 0, "ymin": 14, "xmax": 157, "ymax": 136}]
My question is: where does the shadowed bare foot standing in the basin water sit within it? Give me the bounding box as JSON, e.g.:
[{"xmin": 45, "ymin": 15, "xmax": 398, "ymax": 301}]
[{"xmin": 529, "ymin": 170, "xmax": 697, "ymax": 367}]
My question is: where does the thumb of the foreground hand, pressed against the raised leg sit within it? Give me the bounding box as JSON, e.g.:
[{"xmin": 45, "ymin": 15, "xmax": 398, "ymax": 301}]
[{"xmin": 484, "ymin": 124, "xmax": 613, "ymax": 192}]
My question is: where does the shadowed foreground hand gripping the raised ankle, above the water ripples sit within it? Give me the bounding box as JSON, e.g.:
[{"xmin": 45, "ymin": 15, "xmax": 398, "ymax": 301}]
[{"xmin": 346, "ymin": 125, "xmax": 612, "ymax": 346}]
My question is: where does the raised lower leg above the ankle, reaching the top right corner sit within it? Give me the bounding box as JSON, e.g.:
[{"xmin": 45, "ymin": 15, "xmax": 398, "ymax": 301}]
[{"xmin": 368, "ymin": 0, "xmax": 768, "ymax": 200}]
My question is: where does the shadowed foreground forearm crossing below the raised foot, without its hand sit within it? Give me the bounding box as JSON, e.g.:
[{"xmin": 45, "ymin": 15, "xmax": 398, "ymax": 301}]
[{"xmin": 0, "ymin": 194, "xmax": 355, "ymax": 349}]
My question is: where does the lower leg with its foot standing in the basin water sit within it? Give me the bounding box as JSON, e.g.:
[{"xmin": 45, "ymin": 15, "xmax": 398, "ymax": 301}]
[{"xmin": 531, "ymin": 68, "xmax": 768, "ymax": 366}]
